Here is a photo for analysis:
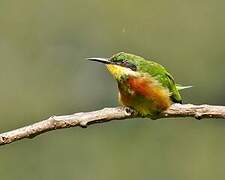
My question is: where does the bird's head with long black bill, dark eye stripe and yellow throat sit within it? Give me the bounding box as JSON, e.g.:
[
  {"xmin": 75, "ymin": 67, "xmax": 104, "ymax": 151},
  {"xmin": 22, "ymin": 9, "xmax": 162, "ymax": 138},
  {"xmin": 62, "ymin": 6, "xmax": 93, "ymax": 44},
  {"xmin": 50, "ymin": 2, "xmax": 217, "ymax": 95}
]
[{"xmin": 88, "ymin": 52, "xmax": 143, "ymax": 80}]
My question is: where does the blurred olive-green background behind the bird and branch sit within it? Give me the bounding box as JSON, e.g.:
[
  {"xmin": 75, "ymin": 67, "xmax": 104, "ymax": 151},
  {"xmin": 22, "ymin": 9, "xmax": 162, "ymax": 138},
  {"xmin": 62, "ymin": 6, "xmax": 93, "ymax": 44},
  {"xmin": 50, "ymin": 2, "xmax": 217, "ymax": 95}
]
[{"xmin": 0, "ymin": 0, "xmax": 225, "ymax": 180}]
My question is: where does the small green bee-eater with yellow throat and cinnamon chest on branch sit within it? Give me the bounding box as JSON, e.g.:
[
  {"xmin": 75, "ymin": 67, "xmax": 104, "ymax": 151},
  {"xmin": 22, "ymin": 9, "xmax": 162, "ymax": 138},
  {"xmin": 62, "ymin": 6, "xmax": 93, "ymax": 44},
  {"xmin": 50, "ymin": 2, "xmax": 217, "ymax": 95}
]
[{"xmin": 88, "ymin": 52, "xmax": 191, "ymax": 117}]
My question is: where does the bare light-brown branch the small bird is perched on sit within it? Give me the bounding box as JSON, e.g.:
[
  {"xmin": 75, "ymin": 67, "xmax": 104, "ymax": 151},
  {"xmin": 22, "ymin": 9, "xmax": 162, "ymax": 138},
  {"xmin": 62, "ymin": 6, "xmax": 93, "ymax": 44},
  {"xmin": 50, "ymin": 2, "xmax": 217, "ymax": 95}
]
[{"xmin": 0, "ymin": 104, "xmax": 225, "ymax": 145}]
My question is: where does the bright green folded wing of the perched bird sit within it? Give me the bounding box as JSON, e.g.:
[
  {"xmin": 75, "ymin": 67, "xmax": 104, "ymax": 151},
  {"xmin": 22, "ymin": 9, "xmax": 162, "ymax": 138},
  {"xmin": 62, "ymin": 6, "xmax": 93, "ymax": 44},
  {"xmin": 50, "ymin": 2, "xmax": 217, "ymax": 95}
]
[{"xmin": 139, "ymin": 61, "xmax": 182, "ymax": 103}]
